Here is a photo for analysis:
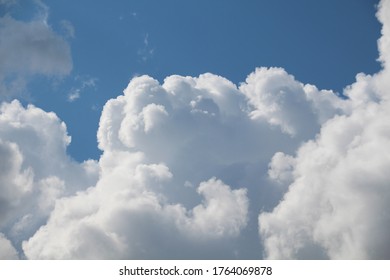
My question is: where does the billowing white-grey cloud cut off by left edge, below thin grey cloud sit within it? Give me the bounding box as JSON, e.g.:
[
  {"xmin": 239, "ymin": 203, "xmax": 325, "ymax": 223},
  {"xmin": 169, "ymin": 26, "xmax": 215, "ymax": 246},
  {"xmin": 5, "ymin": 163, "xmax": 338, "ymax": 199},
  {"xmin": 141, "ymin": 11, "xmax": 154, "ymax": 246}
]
[{"xmin": 0, "ymin": 101, "xmax": 98, "ymax": 253}]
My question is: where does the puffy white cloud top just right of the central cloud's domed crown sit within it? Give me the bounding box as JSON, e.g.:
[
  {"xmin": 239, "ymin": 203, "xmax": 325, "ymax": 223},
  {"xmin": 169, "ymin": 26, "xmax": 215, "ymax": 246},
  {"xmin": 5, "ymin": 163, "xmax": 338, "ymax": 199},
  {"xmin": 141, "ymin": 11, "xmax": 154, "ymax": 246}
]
[{"xmin": 240, "ymin": 67, "xmax": 346, "ymax": 136}]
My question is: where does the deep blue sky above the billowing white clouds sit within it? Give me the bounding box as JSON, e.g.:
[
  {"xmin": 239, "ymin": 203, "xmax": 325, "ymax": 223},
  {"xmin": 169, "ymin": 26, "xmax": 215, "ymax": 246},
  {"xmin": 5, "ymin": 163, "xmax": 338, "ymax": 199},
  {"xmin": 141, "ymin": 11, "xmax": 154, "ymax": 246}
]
[{"xmin": 3, "ymin": 0, "xmax": 380, "ymax": 160}]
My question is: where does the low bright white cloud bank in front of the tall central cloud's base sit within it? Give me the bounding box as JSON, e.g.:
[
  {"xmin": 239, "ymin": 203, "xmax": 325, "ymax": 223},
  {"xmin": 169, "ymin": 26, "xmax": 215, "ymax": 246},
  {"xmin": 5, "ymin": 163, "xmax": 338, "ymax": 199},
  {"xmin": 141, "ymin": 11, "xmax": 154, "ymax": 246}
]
[{"xmin": 23, "ymin": 170, "xmax": 247, "ymax": 259}]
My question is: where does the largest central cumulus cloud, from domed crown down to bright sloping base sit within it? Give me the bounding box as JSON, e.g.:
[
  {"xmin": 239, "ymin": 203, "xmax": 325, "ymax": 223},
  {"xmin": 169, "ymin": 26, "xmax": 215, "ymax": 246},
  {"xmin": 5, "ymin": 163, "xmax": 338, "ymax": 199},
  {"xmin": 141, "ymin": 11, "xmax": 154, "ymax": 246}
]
[{"xmin": 23, "ymin": 71, "xmax": 280, "ymax": 258}]
